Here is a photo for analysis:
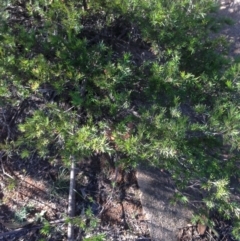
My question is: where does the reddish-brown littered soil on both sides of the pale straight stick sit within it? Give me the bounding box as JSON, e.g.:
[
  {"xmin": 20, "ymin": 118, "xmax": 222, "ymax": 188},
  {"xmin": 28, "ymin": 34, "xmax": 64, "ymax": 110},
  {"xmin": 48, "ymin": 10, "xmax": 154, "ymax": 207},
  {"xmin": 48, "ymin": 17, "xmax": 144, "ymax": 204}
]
[{"xmin": 0, "ymin": 153, "xmax": 149, "ymax": 240}]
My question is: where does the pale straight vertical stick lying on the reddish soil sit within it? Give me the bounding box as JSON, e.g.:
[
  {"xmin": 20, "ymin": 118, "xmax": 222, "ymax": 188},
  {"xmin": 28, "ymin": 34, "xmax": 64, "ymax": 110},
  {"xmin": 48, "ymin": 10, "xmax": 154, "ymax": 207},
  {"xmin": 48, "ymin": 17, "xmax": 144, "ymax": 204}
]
[{"xmin": 67, "ymin": 157, "xmax": 76, "ymax": 241}]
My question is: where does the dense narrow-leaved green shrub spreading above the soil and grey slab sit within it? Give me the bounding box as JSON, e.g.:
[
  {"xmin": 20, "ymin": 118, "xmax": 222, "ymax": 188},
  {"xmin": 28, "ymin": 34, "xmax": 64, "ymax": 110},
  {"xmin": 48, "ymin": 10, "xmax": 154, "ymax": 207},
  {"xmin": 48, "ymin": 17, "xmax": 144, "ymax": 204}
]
[{"xmin": 0, "ymin": 0, "xmax": 240, "ymax": 240}]
